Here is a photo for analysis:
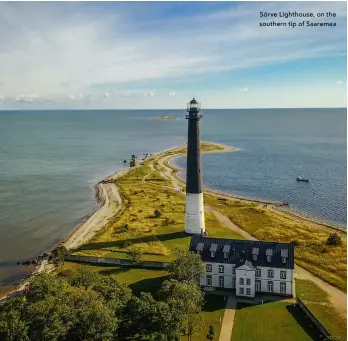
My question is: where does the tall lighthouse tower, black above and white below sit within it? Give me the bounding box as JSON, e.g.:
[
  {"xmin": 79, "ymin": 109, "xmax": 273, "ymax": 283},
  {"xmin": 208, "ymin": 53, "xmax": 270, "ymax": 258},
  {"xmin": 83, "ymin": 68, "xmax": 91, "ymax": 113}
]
[{"xmin": 185, "ymin": 98, "xmax": 205, "ymax": 234}]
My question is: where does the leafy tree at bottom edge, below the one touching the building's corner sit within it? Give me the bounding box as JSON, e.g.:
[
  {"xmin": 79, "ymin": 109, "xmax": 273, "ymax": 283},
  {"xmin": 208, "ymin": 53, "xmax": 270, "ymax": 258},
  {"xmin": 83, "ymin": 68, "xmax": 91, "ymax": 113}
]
[{"xmin": 159, "ymin": 279, "xmax": 204, "ymax": 340}]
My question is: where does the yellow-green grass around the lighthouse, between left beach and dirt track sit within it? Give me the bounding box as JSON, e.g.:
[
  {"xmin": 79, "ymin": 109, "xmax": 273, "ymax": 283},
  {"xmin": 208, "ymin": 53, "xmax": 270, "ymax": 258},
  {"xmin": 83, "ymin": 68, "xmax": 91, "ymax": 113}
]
[{"xmin": 75, "ymin": 144, "xmax": 245, "ymax": 262}]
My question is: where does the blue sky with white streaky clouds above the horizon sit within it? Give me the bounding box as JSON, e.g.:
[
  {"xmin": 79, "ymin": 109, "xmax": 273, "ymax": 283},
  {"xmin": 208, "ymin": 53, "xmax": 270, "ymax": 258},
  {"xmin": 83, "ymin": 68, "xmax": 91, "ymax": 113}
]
[{"xmin": 0, "ymin": 1, "xmax": 347, "ymax": 110}]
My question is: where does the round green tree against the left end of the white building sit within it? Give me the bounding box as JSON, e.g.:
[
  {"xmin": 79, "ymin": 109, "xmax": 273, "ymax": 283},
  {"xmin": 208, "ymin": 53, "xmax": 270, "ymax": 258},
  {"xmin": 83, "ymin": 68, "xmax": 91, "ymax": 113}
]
[{"xmin": 168, "ymin": 251, "xmax": 205, "ymax": 283}]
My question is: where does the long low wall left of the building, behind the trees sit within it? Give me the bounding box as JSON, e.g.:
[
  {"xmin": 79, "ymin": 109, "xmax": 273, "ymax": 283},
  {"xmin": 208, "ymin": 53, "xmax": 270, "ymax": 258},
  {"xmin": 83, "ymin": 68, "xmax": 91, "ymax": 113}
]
[{"xmin": 66, "ymin": 255, "xmax": 169, "ymax": 269}]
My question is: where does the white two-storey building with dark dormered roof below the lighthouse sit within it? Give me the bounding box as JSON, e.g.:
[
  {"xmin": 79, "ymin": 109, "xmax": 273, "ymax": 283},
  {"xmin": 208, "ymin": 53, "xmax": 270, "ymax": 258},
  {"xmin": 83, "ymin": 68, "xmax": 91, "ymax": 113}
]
[{"xmin": 190, "ymin": 236, "xmax": 294, "ymax": 298}]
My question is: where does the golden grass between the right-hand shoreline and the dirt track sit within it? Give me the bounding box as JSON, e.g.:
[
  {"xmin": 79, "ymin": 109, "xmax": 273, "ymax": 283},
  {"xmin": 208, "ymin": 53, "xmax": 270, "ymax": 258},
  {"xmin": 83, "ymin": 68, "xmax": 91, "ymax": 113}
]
[{"xmin": 204, "ymin": 194, "xmax": 347, "ymax": 291}]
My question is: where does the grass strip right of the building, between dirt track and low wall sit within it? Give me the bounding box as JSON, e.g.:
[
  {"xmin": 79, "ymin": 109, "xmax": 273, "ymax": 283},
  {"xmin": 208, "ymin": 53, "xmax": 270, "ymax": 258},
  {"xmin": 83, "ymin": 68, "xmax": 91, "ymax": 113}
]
[{"xmin": 296, "ymin": 279, "xmax": 347, "ymax": 339}]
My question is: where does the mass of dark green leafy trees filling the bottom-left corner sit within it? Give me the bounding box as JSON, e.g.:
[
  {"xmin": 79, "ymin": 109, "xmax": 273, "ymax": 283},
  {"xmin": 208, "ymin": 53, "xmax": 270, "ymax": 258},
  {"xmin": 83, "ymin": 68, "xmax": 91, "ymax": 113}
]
[{"xmin": 0, "ymin": 253, "xmax": 222, "ymax": 341}]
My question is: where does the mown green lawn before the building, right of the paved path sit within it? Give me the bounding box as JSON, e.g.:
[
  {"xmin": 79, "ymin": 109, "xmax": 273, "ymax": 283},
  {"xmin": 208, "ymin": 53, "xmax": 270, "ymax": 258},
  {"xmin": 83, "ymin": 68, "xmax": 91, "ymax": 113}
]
[{"xmin": 231, "ymin": 302, "xmax": 318, "ymax": 341}]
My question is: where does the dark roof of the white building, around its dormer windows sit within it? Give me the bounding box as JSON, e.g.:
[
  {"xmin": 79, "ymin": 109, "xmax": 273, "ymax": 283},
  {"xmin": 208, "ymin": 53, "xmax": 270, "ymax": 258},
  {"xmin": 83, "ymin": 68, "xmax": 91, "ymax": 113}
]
[{"xmin": 189, "ymin": 236, "xmax": 294, "ymax": 269}]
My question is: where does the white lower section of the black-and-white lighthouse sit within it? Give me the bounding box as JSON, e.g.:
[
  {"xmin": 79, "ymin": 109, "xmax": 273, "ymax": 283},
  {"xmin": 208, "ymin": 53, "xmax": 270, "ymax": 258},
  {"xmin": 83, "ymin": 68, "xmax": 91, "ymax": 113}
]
[{"xmin": 185, "ymin": 193, "xmax": 205, "ymax": 234}]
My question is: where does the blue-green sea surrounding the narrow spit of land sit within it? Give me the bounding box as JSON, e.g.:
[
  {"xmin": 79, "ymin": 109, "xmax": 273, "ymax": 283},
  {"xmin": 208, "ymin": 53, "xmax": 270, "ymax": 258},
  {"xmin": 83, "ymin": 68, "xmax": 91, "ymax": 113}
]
[{"xmin": 0, "ymin": 108, "xmax": 347, "ymax": 293}]
